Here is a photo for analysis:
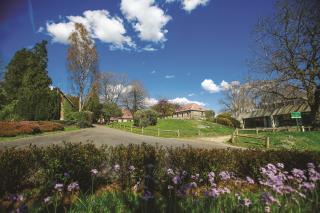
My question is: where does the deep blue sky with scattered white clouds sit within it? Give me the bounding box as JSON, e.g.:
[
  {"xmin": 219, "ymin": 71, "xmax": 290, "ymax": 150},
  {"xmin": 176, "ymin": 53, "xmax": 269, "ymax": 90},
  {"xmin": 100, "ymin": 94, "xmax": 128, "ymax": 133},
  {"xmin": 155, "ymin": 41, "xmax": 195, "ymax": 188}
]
[{"xmin": 0, "ymin": 0, "xmax": 274, "ymax": 111}]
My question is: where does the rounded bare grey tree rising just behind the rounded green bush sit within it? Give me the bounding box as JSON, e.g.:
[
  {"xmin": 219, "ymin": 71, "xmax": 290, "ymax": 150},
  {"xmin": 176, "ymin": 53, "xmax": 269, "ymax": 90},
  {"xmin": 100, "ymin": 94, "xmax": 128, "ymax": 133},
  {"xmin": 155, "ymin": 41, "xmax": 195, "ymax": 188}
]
[{"xmin": 122, "ymin": 81, "xmax": 147, "ymax": 114}]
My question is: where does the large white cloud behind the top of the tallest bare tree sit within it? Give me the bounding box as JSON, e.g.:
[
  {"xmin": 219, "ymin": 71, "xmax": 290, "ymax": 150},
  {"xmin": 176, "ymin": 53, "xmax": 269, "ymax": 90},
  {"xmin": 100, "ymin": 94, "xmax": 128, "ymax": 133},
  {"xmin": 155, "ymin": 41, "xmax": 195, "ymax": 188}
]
[{"xmin": 46, "ymin": 10, "xmax": 135, "ymax": 48}]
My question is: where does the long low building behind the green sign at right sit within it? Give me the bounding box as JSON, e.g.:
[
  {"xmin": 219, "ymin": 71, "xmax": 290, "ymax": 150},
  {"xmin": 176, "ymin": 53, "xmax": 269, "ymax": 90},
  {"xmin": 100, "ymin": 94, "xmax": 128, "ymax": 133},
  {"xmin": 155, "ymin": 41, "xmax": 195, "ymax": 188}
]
[{"xmin": 236, "ymin": 103, "xmax": 311, "ymax": 128}]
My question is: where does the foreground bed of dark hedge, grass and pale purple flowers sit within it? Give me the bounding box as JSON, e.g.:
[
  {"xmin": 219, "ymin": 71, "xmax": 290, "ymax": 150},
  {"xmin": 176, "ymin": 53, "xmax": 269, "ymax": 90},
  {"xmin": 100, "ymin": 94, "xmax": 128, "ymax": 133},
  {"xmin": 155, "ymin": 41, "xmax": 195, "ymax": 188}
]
[{"xmin": 0, "ymin": 144, "xmax": 320, "ymax": 212}]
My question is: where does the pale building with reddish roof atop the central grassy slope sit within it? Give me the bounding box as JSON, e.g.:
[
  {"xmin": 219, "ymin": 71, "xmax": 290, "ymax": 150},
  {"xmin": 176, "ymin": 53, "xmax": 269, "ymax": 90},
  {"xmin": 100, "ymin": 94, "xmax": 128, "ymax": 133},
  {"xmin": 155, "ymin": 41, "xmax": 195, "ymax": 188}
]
[{"xmin": 172, "ymin": 103, "xmax": 206, "ymax": 120}]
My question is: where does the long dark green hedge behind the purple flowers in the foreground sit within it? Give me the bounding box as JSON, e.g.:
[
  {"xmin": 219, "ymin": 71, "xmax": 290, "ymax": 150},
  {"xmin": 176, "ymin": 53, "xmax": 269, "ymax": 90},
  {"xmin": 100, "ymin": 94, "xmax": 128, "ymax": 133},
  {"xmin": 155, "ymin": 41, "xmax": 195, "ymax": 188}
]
[{"xmin": 0, "ymin": 143, "xmax": 320, "ymax": 199}]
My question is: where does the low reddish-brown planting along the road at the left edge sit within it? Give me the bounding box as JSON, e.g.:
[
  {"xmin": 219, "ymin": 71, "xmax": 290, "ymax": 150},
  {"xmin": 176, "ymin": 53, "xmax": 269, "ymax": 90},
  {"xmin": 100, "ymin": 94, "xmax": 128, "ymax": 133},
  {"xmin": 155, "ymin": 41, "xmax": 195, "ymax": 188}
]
[{"xmin": 0, "ymin": 121, "xmax": 64, "ymax": 137}]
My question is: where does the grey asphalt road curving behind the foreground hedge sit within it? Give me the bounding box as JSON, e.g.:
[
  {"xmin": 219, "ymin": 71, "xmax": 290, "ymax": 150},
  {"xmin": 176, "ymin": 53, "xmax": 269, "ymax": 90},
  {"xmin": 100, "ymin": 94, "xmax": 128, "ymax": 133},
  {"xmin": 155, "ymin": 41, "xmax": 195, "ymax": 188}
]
[{"xmin": 0, "ymin": 126, "xmax": 232, "ymax": 149}]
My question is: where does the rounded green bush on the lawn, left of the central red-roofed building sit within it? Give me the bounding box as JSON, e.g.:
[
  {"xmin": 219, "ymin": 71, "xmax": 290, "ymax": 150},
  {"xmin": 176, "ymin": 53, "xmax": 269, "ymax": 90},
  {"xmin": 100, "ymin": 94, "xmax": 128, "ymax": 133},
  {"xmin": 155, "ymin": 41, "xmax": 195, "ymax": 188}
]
[{"xmin": 133, "ymin": 109, "xmax": 158, "ymax": 127}]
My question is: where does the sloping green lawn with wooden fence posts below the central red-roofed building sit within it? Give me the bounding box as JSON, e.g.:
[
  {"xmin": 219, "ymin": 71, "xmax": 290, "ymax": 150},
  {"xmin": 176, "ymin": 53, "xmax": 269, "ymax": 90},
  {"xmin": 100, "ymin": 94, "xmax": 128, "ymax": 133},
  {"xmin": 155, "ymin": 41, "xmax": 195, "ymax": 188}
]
[{"xmin": 109, "ymin": 119, "xmax": 234, "ymax": 137}]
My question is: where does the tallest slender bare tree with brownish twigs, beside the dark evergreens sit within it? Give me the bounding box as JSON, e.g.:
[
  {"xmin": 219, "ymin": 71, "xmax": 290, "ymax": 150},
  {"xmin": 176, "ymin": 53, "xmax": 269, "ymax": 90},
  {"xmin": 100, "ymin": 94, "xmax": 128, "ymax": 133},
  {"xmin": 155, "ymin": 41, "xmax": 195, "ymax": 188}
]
[{"xmin": 67, "ymin": 23, "xmax": 98, "ymax": 111}]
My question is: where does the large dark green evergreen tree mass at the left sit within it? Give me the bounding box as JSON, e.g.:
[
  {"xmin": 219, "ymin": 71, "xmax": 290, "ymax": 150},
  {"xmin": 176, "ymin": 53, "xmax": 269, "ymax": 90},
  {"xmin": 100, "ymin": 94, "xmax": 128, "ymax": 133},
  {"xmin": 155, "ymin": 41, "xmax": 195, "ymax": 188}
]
[{"xmin": 0, "ymin": 41, "xmax": 59, "ymax": 120}]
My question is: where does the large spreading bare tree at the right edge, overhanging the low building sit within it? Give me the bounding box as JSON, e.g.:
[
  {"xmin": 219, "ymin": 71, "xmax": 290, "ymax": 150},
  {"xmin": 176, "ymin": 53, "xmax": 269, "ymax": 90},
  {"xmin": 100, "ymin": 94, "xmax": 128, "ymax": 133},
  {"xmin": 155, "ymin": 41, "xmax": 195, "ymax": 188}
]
[{"xmin": 254, "ymin": 0, "xmax": 320, "ymax": 128}]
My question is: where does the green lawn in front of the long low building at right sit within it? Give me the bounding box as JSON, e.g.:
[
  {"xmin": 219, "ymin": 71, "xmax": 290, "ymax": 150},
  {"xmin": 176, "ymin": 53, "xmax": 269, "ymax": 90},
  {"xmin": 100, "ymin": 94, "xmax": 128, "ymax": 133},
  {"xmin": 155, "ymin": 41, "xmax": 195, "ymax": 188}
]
[{"xmin": 232, "ymin": 131, "xmax": 320, "ymax": 151}]
